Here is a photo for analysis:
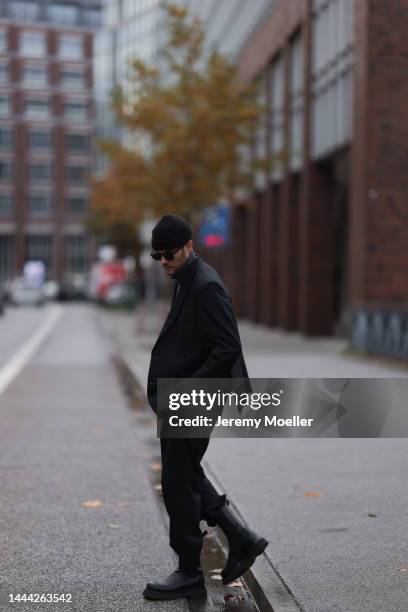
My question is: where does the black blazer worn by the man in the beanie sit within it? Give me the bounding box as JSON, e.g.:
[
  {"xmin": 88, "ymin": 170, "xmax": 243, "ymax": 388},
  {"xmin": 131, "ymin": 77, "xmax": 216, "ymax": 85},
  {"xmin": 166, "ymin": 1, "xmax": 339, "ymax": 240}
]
[{"xmin": 147, "ymin": 256, "xmax": 248, "ymax": 412}]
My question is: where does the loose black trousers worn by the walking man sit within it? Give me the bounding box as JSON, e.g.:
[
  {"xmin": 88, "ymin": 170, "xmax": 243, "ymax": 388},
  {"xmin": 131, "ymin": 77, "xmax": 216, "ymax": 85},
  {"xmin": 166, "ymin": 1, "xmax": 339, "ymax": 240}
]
[{"xmin": 160, "ymin": 438, "xmax": 226, "ymax": 569}]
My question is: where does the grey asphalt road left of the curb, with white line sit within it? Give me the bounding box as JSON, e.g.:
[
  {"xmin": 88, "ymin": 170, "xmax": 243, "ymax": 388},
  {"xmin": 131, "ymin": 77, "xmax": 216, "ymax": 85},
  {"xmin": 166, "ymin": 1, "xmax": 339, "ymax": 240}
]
[{"xmin": 0, "ymin": 305, "xmax": 187, "ymax": 612}]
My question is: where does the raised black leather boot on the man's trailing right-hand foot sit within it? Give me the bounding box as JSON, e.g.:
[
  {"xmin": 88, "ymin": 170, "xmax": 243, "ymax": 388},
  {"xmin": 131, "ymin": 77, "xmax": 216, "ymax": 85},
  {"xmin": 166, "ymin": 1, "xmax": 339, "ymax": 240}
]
[{"xmin": 217, "ymin": 505, "xmax": 268, "ymax": 584}]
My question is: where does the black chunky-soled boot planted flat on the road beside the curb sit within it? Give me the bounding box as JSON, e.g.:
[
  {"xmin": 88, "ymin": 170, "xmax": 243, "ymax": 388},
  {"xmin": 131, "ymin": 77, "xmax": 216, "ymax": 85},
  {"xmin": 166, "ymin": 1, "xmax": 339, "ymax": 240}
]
[{"xmin": 143, "ymin": 567, "xmax": 207, "ymax": 600}]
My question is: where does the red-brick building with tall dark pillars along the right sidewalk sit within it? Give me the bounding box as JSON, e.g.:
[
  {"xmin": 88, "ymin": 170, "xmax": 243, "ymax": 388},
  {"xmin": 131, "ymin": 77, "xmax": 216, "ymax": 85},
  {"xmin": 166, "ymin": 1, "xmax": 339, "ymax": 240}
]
[{"xmin": 185, "ymin": 0, "xmax": 408, "ymax": 356}]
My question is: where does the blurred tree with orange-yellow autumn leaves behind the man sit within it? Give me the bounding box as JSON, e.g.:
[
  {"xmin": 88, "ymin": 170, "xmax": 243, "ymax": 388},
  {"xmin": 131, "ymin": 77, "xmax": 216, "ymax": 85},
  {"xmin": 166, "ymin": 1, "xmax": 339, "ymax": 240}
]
[{"xmin": 92, "ymin": 5, "xmax": 266, "ymax": 239}]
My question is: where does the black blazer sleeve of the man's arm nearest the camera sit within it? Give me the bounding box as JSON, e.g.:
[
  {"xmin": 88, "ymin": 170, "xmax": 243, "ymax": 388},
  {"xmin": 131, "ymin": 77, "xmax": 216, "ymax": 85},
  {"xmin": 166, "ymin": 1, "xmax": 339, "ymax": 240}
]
[{"xmin": 192, "ymin": 283, "xmax": 242, "ymax": 378}]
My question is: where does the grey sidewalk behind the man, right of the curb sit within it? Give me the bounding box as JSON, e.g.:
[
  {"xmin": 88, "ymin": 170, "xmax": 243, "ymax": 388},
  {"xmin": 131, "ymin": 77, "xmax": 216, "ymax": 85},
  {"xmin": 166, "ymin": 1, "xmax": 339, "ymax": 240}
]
[{"xmin": 101, "ymin": 304, "xmax": 408, "ymax": 612}]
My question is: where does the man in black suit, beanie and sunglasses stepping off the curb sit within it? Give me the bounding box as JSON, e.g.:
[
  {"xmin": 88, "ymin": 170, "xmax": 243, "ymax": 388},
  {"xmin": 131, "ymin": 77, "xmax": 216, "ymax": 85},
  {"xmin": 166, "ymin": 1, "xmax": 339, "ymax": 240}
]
[{"xmin": 143, "ymin": 215, "xmax": 268, "ymax": 599}]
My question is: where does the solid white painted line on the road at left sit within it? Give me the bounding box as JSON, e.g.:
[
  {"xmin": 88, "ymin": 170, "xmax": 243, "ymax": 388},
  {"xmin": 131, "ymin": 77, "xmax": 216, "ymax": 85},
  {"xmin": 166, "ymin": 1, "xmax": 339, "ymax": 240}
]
[{"xmin": 0, "ymin": 306, "xmax": 63, "ymax": 395}]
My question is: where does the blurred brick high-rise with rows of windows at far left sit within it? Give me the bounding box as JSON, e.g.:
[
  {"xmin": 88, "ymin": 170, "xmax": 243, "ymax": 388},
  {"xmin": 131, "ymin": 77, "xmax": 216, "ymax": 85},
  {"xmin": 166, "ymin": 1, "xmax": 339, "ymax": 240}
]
[{"xmin": 0, "ymin": 0, "xmax": 101, "ymax": 281}]
